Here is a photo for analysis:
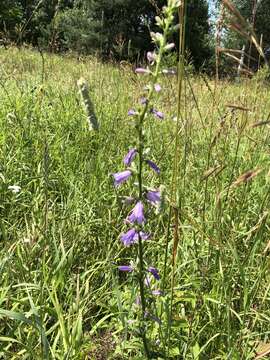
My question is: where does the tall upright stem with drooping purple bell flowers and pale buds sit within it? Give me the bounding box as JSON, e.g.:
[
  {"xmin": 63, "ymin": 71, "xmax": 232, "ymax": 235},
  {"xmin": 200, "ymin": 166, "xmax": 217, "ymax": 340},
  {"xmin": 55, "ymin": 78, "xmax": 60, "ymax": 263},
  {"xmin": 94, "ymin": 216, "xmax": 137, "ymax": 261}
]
[{"xmin": 112, "ymin": 0, "xmax": 180, "ymax": 359}]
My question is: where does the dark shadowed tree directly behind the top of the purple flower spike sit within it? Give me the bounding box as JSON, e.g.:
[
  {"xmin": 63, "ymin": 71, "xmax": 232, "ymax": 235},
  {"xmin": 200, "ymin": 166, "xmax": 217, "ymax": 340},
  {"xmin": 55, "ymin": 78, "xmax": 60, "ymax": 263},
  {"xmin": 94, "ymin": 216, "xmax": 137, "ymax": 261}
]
[{"xmin": 83, "ymin": 0, "xmax": 211, "ymax": 68}]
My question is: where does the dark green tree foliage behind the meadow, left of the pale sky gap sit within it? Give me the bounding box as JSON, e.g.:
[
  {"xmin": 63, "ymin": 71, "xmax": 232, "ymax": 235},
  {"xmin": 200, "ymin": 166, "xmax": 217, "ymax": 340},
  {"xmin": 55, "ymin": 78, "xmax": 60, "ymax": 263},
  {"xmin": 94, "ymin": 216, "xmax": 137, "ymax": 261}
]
[{"xmin": 0, "ymin": 0, "xmax": 210, "ymax": 66}]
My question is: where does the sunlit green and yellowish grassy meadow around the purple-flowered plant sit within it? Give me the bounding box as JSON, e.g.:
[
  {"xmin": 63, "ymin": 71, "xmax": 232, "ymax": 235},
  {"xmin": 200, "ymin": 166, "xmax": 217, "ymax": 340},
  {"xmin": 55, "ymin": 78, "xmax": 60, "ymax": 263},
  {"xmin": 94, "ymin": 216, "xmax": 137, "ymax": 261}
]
[{"xmin": 0, "ymin": 48, "xmax": 270, "ymax": 360}]
